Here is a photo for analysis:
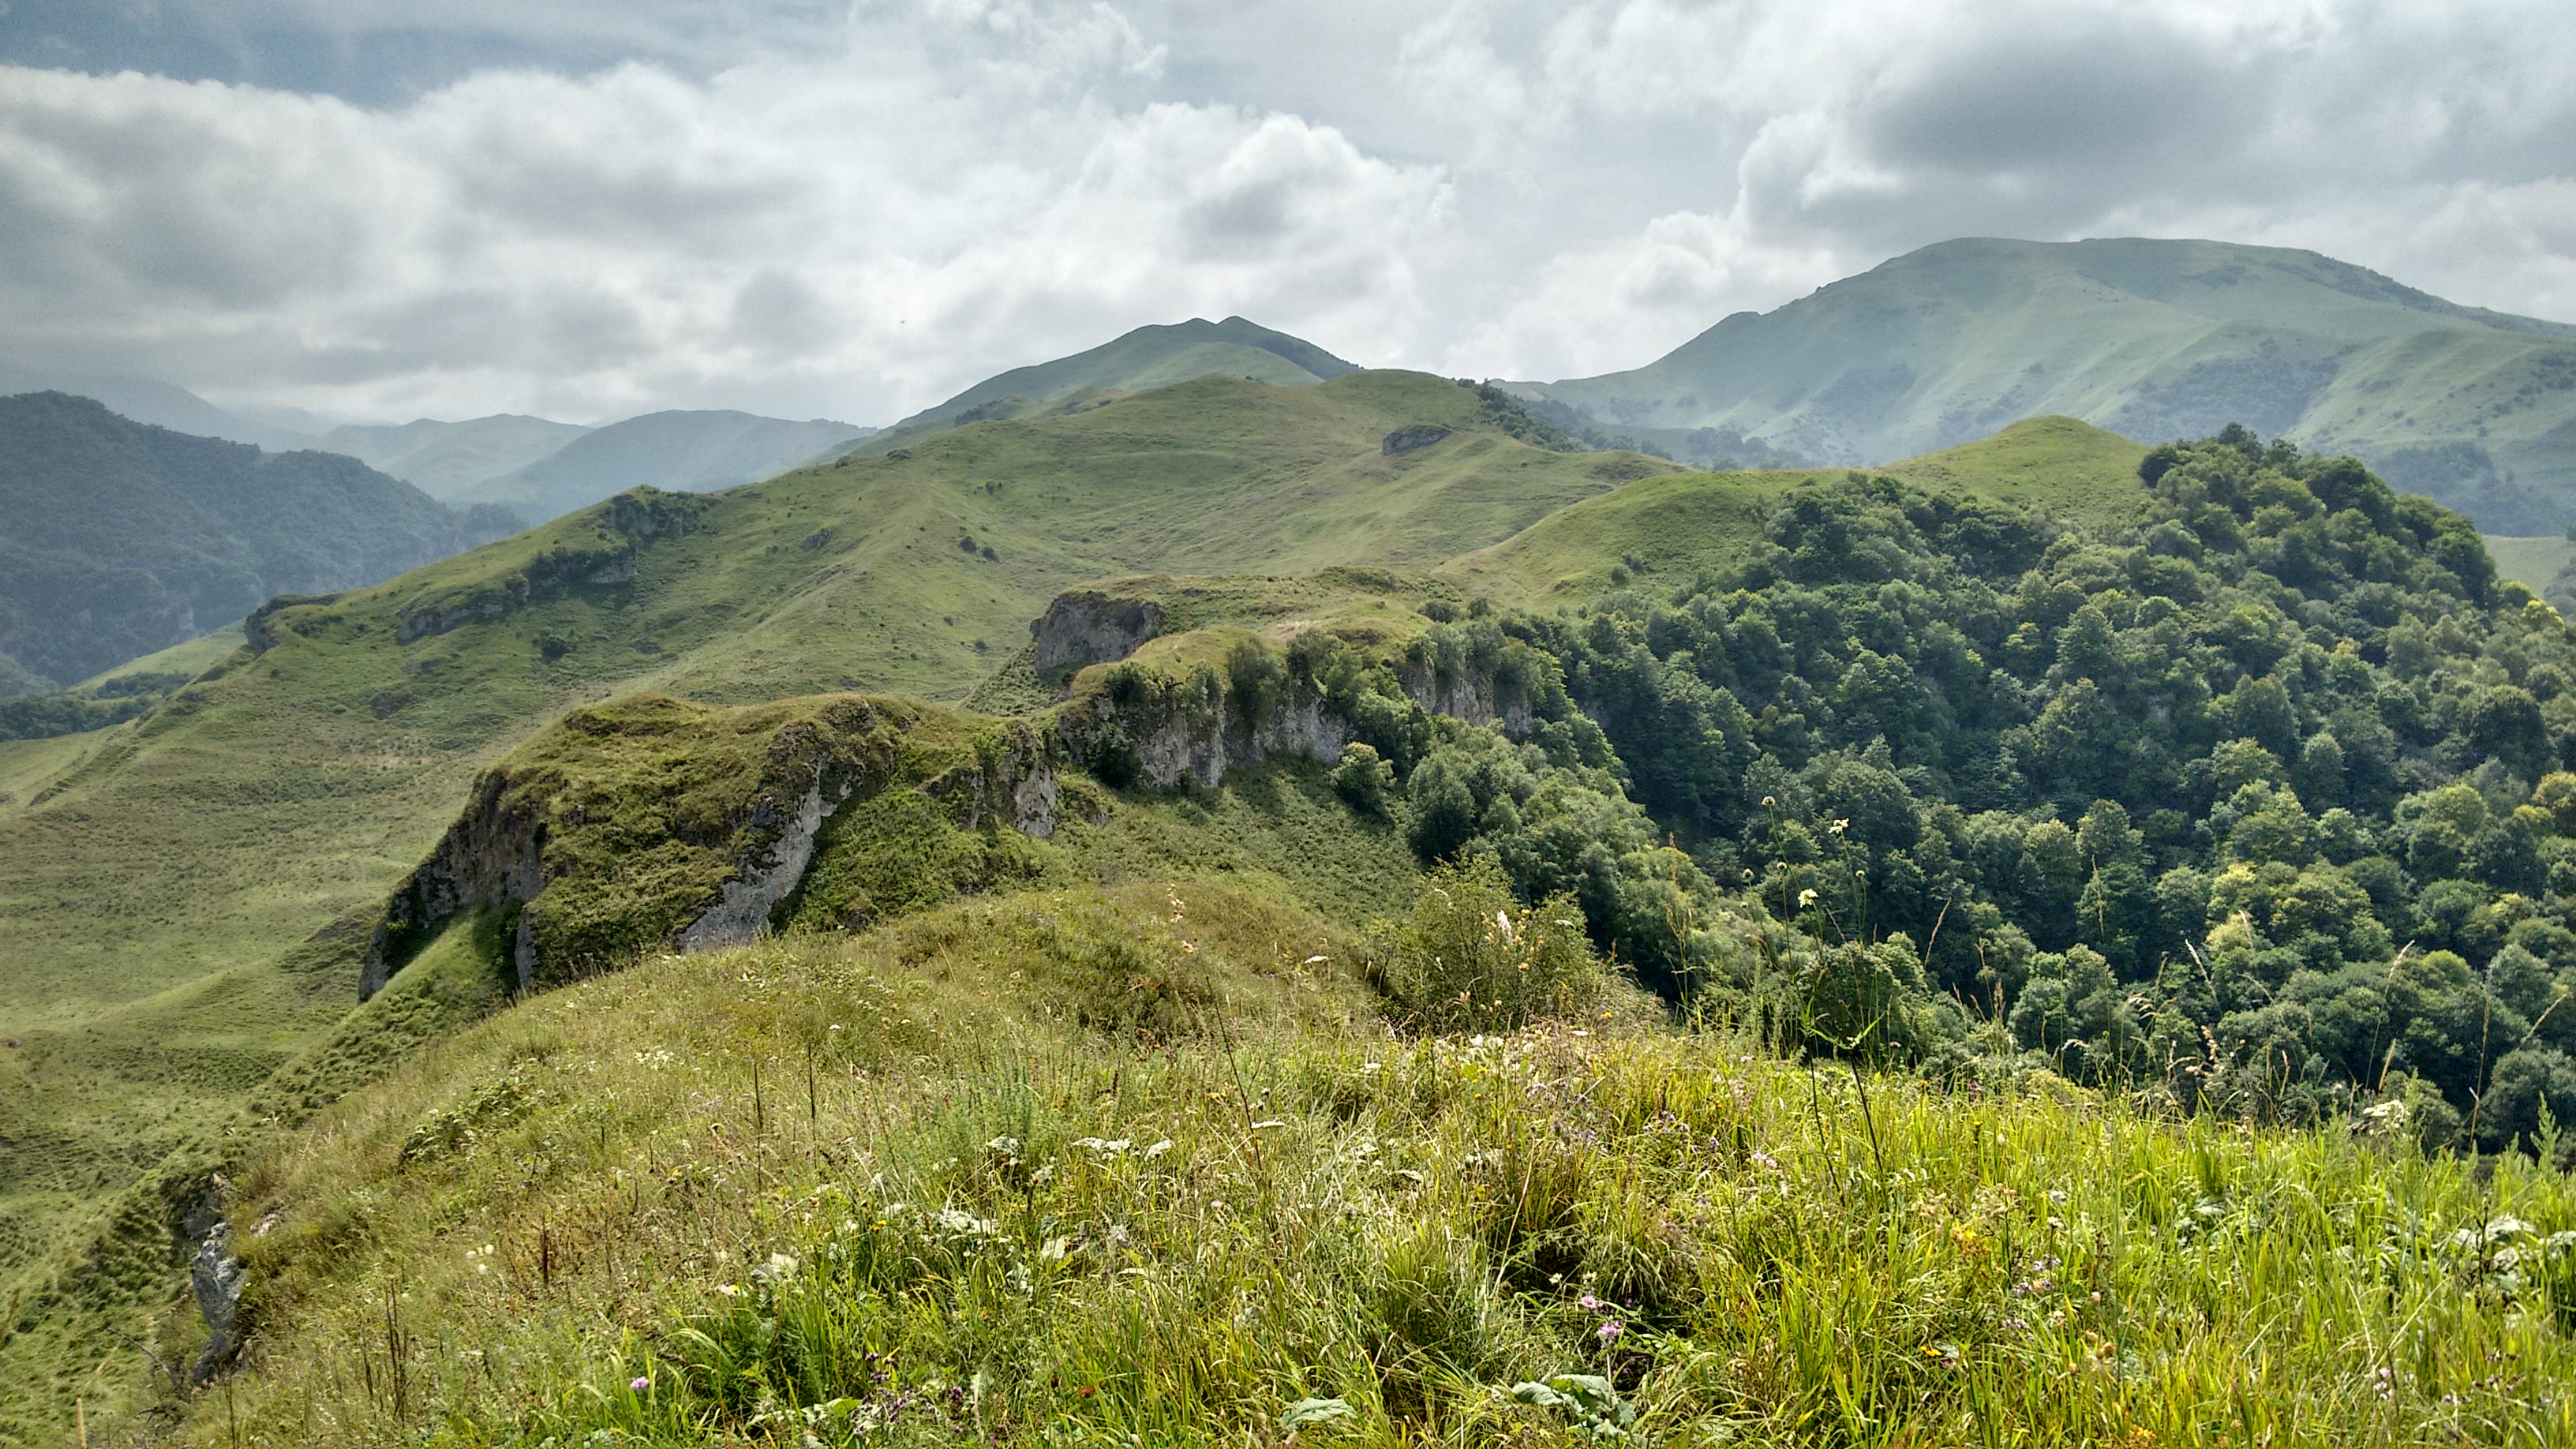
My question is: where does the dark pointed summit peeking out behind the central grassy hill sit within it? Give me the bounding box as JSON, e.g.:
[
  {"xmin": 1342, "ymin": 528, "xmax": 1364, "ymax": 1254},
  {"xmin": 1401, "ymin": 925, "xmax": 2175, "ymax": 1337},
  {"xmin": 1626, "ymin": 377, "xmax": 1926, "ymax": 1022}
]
[{"xmin": 845, "ymin": 317, "xmax": 1357, "ymax": 454}]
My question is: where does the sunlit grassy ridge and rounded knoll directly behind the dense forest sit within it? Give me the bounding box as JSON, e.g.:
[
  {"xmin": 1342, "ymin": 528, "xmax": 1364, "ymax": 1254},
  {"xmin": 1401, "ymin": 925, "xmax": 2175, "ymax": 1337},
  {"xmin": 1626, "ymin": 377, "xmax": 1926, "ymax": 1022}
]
[{"xmin": 1437, "ymin": 417, "xmax": 2146, "ymax": 608}]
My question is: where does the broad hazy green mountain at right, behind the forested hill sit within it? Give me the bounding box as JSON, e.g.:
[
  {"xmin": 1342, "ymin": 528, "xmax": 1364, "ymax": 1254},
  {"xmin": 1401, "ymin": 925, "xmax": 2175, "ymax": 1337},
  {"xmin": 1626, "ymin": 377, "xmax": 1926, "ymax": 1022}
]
[{"xmin": 1515, "ymin": 240, "xmax": 2576, "ymax": 534}]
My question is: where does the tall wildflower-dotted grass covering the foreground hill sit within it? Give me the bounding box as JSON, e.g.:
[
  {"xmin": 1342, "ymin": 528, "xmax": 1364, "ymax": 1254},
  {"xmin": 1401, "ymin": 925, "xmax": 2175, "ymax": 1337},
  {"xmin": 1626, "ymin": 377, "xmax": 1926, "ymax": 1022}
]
[{"xmin": 130, "ymin": 887, "xmax": 2576, "ymax": 1449}]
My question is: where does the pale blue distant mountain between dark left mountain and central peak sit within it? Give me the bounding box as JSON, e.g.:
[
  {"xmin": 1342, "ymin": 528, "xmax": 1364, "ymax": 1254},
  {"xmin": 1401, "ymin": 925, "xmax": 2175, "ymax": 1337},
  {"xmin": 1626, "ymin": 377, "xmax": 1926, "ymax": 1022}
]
[{"xmin": 453, "ymin": 413, "xmax": 868, "ymax": 521}]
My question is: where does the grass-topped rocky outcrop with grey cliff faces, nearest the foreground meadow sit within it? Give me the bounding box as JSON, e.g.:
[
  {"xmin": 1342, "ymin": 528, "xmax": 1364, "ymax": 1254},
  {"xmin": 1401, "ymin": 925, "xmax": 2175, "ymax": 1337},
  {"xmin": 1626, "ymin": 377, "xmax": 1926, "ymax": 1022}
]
[{"xmin": 361, "ymin": 696, "xmax": 1059, "ymax": 995}]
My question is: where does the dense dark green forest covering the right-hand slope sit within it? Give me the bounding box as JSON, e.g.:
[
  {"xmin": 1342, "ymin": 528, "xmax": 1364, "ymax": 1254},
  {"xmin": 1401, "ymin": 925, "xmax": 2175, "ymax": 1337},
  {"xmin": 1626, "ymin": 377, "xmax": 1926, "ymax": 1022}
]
[{"xmin": 1195, "ymin": 428, "xmax": 2576, "ymax": 1150}]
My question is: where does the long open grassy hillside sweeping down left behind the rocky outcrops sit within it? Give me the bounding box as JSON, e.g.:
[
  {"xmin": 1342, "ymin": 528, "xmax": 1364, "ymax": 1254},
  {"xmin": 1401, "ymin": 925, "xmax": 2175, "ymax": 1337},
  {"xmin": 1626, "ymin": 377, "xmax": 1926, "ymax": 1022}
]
[{"xmin": 0, "ymin": 374, "xmax": 1664, "ymax": 1340}]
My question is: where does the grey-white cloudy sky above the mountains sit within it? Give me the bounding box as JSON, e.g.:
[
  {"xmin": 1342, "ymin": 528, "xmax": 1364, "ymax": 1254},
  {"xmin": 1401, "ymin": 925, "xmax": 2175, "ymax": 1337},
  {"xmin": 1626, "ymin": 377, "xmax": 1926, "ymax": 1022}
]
[{"xmin": 0, "ymin": 0, "xmax": 2576, "ymax": 423}]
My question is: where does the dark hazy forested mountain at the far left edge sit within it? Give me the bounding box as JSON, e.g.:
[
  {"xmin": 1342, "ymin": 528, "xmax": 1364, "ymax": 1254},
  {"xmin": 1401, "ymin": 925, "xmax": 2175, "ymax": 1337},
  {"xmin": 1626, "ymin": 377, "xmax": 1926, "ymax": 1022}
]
[{"xmin": 0, "ymin": 392, "xmax": 515, "ymax": 680}]
